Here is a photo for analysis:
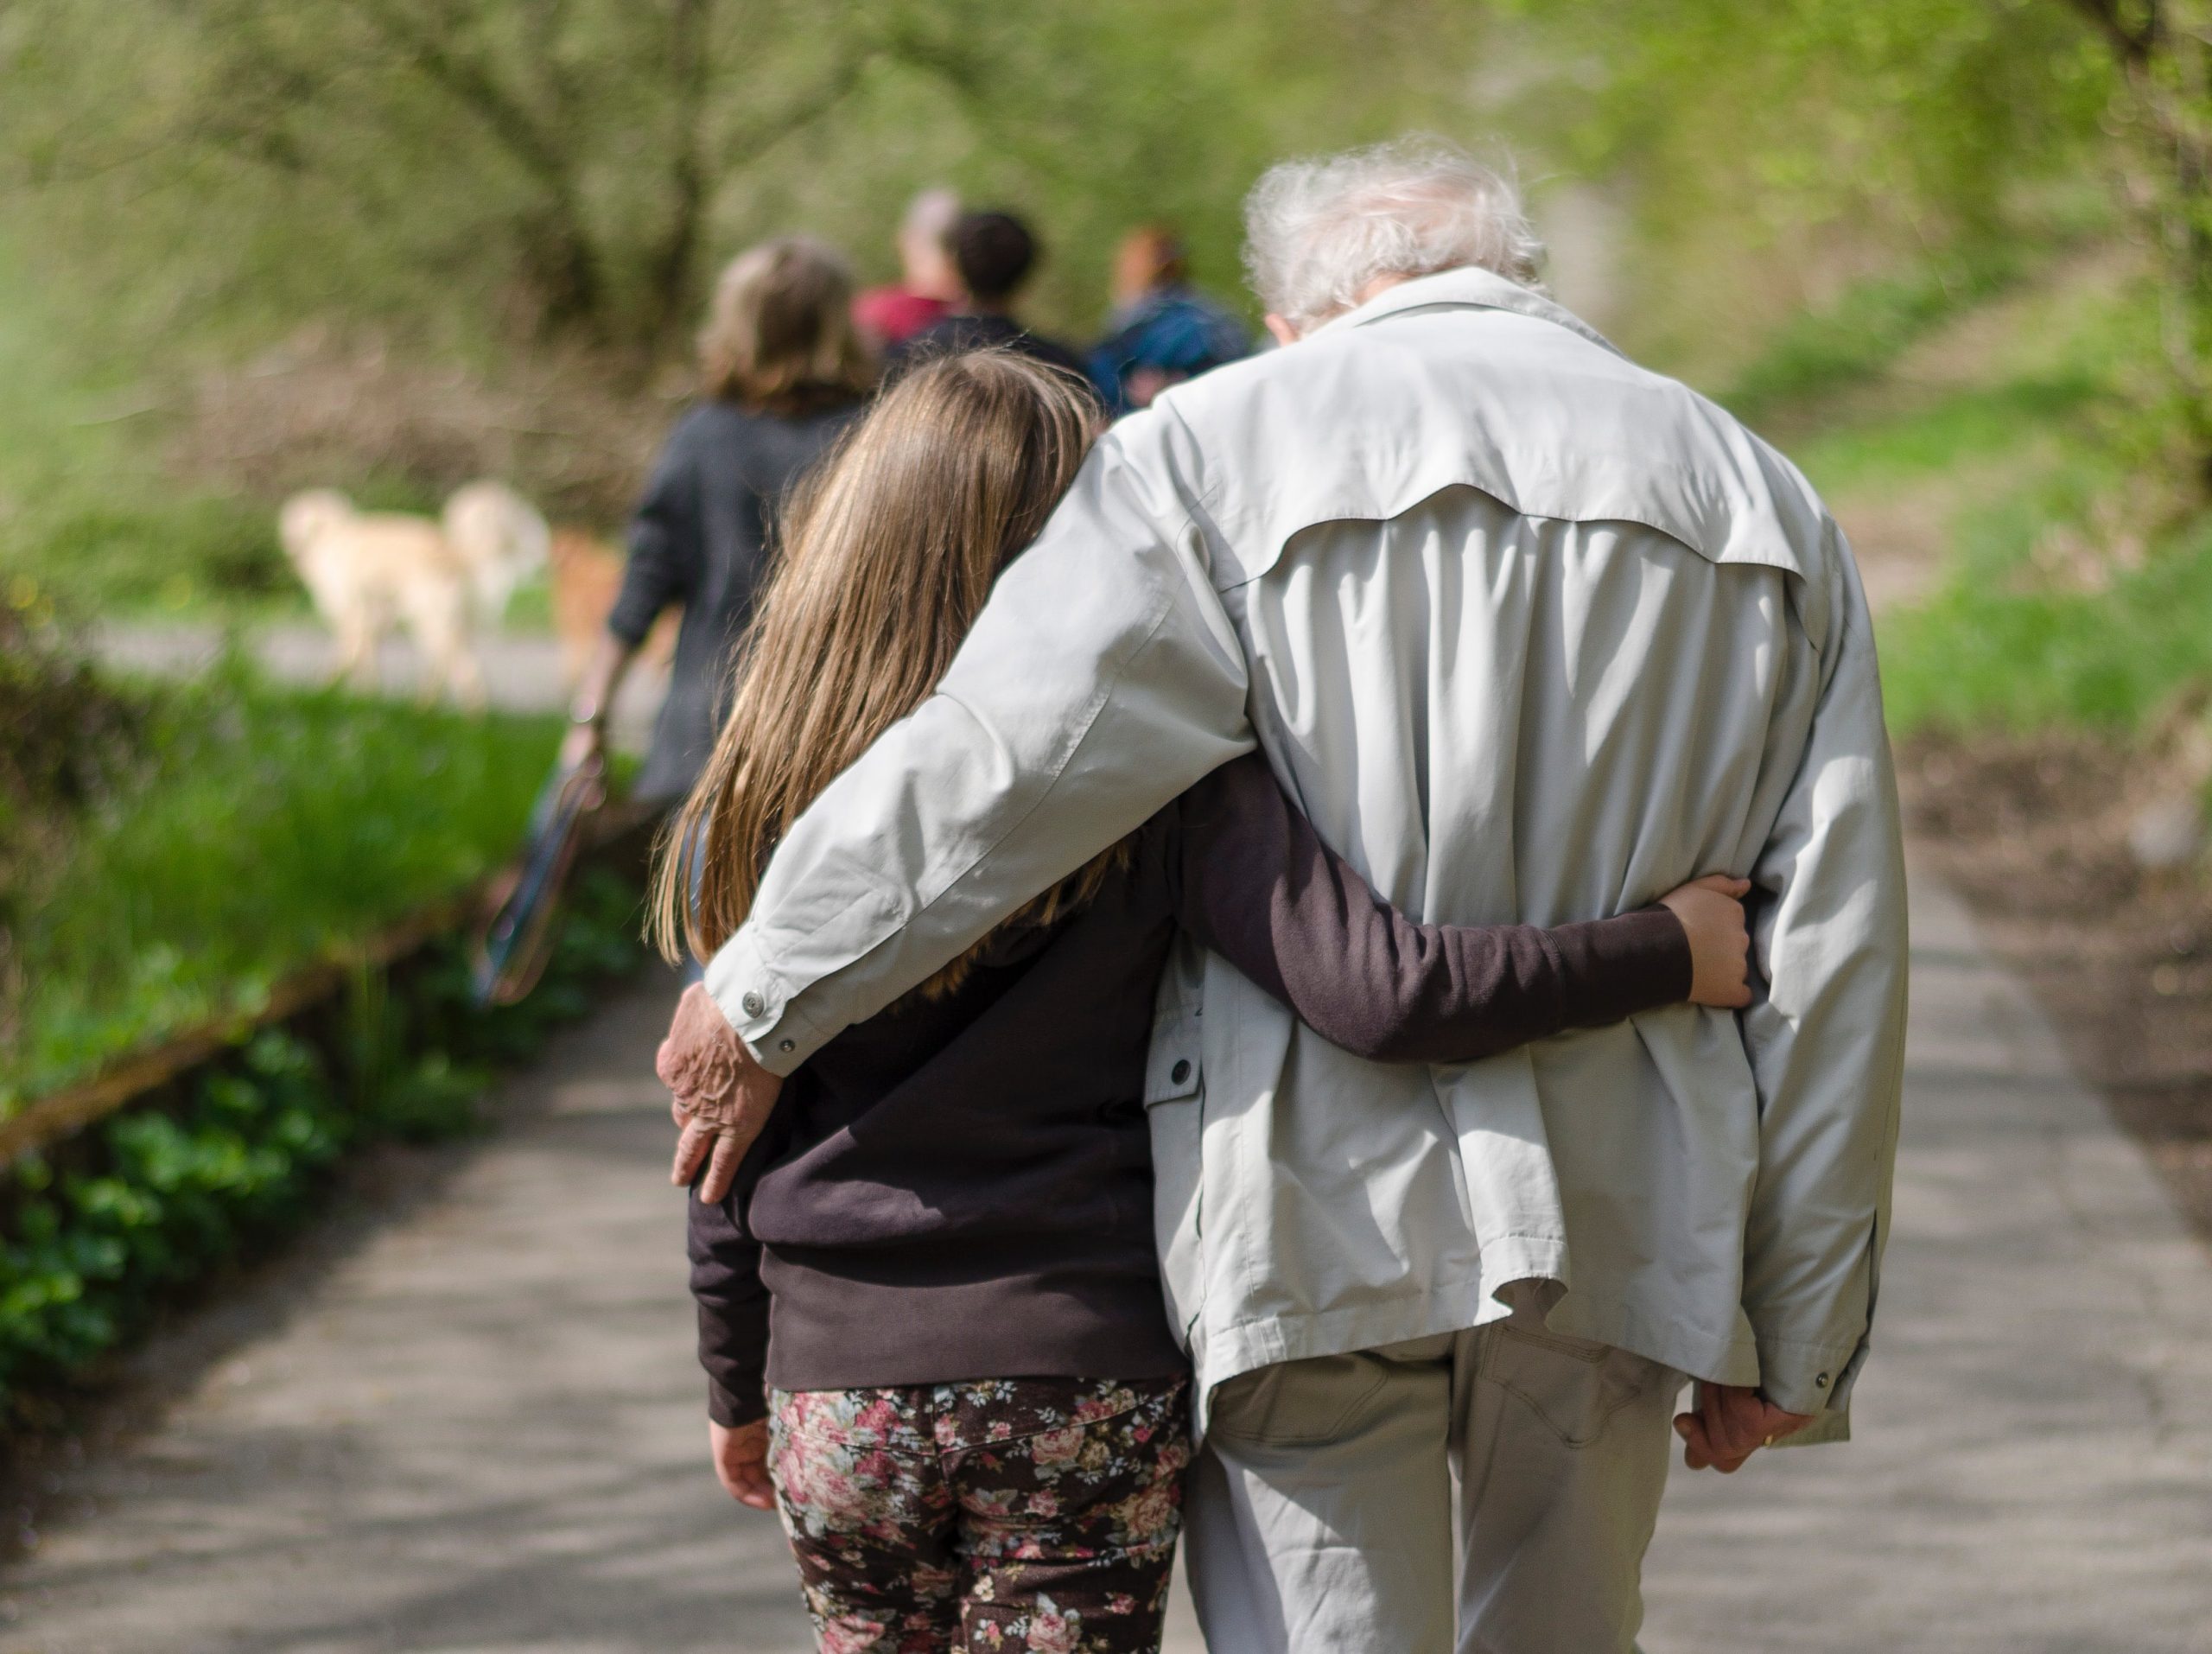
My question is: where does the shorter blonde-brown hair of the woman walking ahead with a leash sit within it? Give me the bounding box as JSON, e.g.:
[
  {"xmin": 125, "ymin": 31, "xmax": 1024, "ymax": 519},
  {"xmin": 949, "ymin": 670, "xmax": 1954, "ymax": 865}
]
[{"xmin": 699, "ymin": 234, "xmax": 876, "ymax": 416}]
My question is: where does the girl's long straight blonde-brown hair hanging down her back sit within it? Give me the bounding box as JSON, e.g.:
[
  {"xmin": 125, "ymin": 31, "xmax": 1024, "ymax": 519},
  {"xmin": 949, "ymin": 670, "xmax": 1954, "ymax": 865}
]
[{"xmin": 648, "ymin": 352, "xmax": 1106, "ymax": 968}]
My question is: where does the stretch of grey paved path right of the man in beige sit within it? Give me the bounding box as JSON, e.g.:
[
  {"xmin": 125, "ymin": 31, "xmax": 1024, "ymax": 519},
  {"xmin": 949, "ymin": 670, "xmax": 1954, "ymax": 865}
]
[{"xmin": 1643, "ymin": 875, "xmax": 2212, "ymax": 1654}]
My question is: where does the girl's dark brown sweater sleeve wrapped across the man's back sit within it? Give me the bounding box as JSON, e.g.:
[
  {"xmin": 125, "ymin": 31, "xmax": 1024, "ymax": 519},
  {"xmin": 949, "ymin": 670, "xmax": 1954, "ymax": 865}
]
[{"xmin": 1173, "ymin": 754, "xmax": 1690, "ymax": 1061}]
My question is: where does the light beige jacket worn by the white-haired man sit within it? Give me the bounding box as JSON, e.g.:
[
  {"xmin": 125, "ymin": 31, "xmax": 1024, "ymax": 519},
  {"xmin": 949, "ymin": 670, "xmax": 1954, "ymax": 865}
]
[{"xmin": 708, "ymin": 270, "xmax": 1904, "ymax": 1440}]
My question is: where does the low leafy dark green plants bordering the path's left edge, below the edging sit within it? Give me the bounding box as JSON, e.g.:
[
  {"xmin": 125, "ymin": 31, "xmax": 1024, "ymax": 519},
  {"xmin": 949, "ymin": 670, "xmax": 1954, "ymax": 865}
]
[{"xmin": 0, "ymin": 869, "xmax": 644, "ymax": 1422}]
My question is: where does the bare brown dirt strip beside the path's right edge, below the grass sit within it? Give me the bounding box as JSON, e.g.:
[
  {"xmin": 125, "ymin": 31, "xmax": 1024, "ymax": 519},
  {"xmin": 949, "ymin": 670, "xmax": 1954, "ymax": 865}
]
[{"xmin": 1897, "ymin": 735, "xmax": 2212, "ymax": 1238}]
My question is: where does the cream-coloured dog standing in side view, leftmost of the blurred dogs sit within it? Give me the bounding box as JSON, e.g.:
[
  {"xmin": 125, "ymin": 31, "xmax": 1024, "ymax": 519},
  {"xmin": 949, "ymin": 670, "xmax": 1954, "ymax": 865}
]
[{"xmin": 276, "ymin": 489, "xmax": 485, "ymax": 708}]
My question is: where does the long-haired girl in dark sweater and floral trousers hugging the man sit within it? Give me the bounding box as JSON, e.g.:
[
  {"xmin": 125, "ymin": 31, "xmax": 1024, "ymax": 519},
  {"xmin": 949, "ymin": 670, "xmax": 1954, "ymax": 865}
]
[{"xmin": 652, "ymin": 352, "xmax": 1747, "ymax": 1654}]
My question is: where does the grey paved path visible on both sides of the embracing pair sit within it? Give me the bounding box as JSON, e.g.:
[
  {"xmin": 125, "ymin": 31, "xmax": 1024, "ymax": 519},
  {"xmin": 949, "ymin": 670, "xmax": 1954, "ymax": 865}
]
[{"xmin": 0, "ymin": 880, "xmax": 2212, "ymax": 1654}]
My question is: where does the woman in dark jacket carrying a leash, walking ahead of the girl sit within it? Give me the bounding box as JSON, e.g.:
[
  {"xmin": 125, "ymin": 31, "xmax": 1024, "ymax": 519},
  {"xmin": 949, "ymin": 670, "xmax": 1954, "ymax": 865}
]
[{"xmin": 562, "ymin": 237, "xmax": 874, "ymax": 803}]
